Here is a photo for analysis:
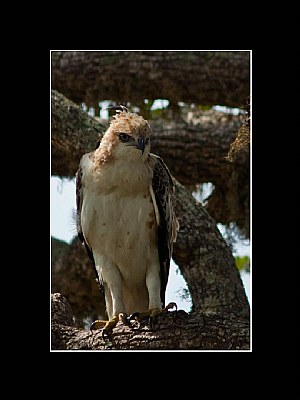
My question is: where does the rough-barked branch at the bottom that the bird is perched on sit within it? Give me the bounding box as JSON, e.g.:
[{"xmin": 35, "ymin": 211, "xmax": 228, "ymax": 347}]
[{"xmin": 51, "ymin": 293, "xmax": 250, "ymax": 351}]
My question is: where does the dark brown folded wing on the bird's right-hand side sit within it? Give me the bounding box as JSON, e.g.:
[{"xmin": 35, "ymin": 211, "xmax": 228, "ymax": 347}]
[{"xmin": 149, "ymin": 153, "xmax": 179, "ymax": 306}]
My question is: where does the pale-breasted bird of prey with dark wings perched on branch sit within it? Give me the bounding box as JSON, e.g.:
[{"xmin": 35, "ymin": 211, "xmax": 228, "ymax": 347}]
[{"xmin": 76, "ymin": 106, "xmax": 179, "ymax": 334}]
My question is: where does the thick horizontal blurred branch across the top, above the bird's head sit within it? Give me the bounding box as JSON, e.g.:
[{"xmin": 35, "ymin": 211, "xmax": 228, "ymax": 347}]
[{"xmin": 51, "ymin": 51, "xmax": 250, "ymax": 108}]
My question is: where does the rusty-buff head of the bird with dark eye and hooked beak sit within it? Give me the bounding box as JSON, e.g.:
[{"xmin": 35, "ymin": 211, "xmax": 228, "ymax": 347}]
[{"xmin": 100, "ymin": 106, "xmax": 151, "ymax": 164}]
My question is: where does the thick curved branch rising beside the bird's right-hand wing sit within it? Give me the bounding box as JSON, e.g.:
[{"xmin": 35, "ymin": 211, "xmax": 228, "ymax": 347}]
[{"xmin": 173, "ymin": 182, "xmax": 250, "ymax": 317}]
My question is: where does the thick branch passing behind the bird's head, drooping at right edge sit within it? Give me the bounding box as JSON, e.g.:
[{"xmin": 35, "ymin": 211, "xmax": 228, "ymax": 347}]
[{"xmin": 51, "ymin": 91, "xmax": 250, "ymax": 238}]
